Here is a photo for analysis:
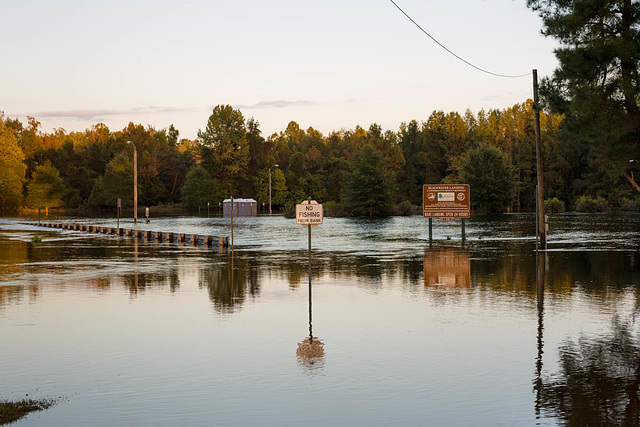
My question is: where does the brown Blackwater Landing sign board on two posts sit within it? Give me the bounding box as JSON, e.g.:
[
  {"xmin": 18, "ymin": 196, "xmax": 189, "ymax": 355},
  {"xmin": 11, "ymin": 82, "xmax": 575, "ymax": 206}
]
[{"xmin": 422, "ymin": 184, "xmax": 471, "ymax": 220}]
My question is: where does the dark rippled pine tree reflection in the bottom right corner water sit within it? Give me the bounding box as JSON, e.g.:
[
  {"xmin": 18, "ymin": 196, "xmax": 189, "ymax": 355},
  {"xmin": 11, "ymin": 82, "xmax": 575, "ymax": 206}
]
[{"xmin": 535, "ymin": 316, "xmax": 640, "ymax": 426}]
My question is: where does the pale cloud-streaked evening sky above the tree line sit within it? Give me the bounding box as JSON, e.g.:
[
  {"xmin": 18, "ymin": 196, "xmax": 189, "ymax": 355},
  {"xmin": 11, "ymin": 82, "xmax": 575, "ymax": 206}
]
[{"xmin": 0, "ymin": 0, "xmax": 557, "ymax": 139}]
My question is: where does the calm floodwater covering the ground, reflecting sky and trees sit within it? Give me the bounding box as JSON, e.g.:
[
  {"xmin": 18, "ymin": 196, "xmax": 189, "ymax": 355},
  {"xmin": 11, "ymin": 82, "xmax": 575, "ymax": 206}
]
[{"xmin": 0, "ymin": 214, "xmax": 640, "ymax": 426}]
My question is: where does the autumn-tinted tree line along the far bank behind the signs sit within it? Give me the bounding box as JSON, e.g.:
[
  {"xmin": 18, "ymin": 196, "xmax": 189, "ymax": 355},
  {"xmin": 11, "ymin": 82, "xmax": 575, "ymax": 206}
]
[{"xmin": 0, "ymin": 100, "xmax": 638, "ymax": 216}]
